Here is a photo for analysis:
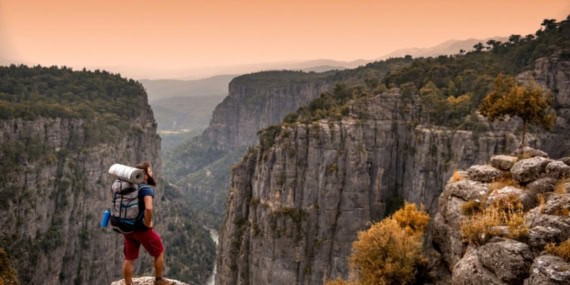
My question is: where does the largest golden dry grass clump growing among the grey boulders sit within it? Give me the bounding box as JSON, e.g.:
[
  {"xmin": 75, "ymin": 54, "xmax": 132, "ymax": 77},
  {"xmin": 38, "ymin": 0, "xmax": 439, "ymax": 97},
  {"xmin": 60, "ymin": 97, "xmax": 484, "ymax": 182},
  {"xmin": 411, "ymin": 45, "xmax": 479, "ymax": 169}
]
[{"xmin": 461, "ymin": 200, "xmax": 528, "ymax": 245}]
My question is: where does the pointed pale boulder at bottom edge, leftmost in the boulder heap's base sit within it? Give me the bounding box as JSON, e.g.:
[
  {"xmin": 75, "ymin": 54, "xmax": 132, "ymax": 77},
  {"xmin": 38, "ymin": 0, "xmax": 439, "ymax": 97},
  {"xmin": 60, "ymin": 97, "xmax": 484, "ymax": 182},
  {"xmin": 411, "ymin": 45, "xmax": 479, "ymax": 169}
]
[{"xmin": 451, "ymin": 248, "xmax": 507, "ymax": 285}]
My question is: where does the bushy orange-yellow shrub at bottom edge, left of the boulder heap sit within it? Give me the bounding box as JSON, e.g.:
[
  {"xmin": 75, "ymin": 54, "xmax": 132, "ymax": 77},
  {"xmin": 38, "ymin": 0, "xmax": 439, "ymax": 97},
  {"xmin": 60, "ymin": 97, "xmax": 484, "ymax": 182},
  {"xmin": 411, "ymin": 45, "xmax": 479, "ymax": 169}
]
[{"xmin": 341, "ymin": 203, "xmax": 429, "ymax": 285}]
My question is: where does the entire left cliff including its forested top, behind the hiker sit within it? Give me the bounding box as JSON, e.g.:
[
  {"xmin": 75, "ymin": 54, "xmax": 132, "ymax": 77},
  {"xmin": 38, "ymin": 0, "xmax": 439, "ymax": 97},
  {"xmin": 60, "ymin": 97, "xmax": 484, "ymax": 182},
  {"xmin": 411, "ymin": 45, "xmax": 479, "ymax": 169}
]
[{"xmin": 0, "ymin": 66, "xmax": 214, "ymax": 284}]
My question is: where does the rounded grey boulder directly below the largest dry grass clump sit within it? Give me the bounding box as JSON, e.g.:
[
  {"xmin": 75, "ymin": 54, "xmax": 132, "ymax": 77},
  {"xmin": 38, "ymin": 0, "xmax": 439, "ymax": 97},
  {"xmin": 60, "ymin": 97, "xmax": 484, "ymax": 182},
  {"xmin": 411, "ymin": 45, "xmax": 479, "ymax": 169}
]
[{"xmin": 477, "ymin": 239, "xmax": 533, "ymax": 284}]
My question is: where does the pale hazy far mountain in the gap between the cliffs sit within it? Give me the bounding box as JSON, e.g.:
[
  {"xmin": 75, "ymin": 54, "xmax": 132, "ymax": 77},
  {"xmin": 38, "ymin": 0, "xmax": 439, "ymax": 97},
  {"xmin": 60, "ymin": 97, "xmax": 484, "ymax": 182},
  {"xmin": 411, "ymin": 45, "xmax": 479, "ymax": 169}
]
[{"xmin": 140, "ymin": 75, "xmax": 236, "ymax": 102}]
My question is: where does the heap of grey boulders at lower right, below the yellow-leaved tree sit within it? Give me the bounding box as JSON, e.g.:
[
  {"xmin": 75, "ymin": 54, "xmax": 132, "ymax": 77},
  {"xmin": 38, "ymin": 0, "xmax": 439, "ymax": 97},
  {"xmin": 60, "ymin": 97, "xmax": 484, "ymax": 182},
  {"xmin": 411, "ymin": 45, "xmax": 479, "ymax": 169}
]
[{"xmin": 432, "ymin": 149, "xmax": 570, "ymax": 285}]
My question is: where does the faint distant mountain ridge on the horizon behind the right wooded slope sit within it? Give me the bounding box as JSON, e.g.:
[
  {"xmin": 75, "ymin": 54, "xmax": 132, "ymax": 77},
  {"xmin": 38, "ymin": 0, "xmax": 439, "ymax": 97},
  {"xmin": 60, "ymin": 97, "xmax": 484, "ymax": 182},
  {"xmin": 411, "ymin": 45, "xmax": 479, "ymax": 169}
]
[{"xmin": 379, "ymin": 37, "xmax": 508, "ymax": 59}]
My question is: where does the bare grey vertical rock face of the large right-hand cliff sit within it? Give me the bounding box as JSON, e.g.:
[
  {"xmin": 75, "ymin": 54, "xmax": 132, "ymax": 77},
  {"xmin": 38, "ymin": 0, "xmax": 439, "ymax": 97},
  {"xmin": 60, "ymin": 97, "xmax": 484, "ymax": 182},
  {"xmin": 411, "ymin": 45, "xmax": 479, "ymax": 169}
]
[{"xmin": 216, "ymin": 52, "xmax": 570, "ymax": 284}]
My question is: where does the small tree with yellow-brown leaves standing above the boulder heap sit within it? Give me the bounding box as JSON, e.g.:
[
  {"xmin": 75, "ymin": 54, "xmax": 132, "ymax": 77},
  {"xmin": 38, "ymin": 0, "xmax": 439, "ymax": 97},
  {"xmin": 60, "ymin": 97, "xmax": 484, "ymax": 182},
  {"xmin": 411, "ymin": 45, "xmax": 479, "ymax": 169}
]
[{"xmin": 479, "ymin": 74, "xmax": 556, "ymax": 148}]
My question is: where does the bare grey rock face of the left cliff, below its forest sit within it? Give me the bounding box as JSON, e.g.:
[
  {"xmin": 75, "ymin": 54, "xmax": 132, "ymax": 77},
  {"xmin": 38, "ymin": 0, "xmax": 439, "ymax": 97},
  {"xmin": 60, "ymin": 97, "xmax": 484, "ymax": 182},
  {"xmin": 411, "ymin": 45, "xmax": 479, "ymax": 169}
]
[{"xmin": 0, "ymin": 115, "xmax": 162, "ymax": 284}]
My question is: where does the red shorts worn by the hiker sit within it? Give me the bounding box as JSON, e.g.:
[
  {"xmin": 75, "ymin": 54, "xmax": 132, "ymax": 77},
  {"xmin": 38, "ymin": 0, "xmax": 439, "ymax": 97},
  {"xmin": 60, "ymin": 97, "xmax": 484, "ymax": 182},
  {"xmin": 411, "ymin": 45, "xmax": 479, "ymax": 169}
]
[{"xmin": 124, "ymin": 229, "xmax": 164, "ymax": 260}]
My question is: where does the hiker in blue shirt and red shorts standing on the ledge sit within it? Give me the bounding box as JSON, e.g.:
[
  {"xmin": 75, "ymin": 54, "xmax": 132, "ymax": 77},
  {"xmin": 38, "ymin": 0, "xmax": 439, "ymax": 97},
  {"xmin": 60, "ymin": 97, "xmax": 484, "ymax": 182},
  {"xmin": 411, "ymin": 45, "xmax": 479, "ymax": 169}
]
[{"xmin": 123, "ymin": 161, "xmax": 174, "ymax": 285}]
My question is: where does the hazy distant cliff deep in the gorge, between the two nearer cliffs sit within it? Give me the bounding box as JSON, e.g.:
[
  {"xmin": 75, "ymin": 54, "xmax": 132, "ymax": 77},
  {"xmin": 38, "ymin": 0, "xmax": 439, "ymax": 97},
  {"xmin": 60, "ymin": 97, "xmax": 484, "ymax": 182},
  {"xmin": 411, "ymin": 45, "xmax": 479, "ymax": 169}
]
[{"xmin": 165, "ymin": 71, "xmax": 331, "ymax": 225}]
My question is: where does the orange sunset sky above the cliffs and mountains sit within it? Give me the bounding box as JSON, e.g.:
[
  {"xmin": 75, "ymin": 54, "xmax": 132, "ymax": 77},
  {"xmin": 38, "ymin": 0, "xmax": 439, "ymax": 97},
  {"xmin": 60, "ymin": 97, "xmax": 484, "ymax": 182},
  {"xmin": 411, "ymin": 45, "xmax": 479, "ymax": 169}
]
[{"xmin": 0, "ymin": 0, "xmax": 570, "ymax": 78}]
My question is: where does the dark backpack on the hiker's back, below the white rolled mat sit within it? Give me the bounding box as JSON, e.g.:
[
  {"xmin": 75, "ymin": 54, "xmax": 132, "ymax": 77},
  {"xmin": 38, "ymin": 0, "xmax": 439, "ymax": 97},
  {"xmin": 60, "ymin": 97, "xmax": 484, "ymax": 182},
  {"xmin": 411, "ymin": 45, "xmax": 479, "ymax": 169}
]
[{"xmin": 110, "ymin": 179, "xmax": 143, "ymax": 234}]
